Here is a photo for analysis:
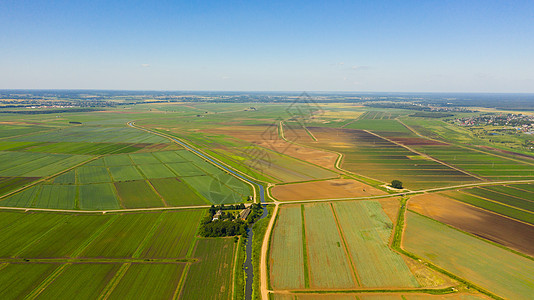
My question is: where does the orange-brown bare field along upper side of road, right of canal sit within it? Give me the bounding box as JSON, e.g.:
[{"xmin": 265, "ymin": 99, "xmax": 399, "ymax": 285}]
[{"xmin": 271, "ymin": 179, "xmax": 386, "ymax": 201}]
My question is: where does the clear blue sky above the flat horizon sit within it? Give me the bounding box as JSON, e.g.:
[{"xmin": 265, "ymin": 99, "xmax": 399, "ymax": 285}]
[{"xmin": 0, "ymin": 0, "xmax": 534, "ymax": 93}]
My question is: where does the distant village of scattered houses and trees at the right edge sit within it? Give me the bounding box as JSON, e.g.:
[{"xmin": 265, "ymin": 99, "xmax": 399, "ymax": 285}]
[{"xmin": 454, "ymin": 114, "xmax": 534, "ymax": 134}]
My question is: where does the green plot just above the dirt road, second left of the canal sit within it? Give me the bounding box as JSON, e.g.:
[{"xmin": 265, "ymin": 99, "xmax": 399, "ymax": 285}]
[{"xmin": 150, "ymin": 178, "xmax": 209, "ymax": 206}]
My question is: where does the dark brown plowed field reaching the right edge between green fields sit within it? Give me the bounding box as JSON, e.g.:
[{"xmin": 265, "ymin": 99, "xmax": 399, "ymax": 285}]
[{"xmin": 408, "ymin": 194, "xmax": 534, "ymax": 256}]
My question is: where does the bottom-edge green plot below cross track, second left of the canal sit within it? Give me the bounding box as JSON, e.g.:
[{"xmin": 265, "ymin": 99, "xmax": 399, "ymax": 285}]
[{"xmin": 108, "ymin": 264, "xmax": 185, "ymax": 299}]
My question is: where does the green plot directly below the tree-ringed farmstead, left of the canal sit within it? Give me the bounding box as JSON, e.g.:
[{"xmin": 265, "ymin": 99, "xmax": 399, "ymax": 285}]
[{"xmin": 180, "ymin": 238, "xmax": 236, "ymax": 300}]
